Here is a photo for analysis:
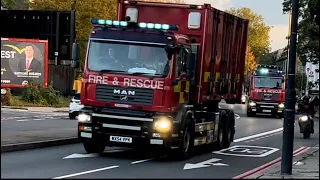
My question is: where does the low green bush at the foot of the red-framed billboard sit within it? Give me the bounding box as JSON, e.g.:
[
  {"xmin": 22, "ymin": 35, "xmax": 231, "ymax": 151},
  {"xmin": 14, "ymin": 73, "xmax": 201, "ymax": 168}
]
[{"xmin": 21, "ymin": 81, "xmax": 69, "ymax": 107}]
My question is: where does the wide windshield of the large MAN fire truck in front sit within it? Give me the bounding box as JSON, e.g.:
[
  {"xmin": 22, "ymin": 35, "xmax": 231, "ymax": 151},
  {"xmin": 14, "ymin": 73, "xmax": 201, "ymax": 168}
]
[{"xmin": 88, "ymin": 40, "xmax": 170, "ymax": 76}]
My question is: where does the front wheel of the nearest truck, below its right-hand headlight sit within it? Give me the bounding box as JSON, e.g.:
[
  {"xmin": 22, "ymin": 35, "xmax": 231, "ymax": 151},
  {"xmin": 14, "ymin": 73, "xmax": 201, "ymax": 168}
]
[{"xmin": 176, "ymin": 126, "xmax": 194, "ymax": 160}]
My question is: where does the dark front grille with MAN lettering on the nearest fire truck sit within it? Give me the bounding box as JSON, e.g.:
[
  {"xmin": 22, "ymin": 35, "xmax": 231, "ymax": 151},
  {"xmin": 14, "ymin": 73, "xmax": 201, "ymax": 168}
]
[{"xmin": 96, "ymin": 84, "xmax": 153, "ymax": 105}]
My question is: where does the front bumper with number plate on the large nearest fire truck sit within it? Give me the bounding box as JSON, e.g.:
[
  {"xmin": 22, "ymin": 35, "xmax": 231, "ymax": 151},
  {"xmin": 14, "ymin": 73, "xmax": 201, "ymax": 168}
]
[{"xmin": 78, "ymin": 113, "xmax": 181, "ymax": 149}]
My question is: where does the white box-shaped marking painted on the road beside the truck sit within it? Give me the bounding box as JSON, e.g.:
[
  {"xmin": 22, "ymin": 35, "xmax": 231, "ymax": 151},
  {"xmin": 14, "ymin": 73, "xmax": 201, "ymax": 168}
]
[{"xmin": 213, "ymin": 145, "xmax": 279, "ymax": 157}]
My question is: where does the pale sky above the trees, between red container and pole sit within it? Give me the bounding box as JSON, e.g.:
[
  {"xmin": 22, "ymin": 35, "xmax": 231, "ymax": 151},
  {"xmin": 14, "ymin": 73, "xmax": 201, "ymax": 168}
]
[{"xmin": 185, "ymin": 0, "xmax": 289, "ymax": 51}]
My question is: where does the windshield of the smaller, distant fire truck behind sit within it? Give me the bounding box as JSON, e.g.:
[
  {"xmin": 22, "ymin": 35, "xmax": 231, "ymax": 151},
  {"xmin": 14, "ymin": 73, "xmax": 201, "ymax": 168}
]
[{"xmin": 254, "ymin": 77, "xmax": 283, "ymax": 89}]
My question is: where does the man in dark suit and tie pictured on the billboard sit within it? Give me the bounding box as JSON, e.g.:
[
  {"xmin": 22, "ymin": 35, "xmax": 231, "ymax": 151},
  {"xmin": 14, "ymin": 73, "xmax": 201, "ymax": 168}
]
[{"xmin": 18, "ymin": 45, "xmax": 42, "ymax": 72}]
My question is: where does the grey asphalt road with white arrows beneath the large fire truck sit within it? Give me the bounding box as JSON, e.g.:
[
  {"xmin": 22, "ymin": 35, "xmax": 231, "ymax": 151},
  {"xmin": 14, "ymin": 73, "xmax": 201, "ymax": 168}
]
[{"xmin": 1, "ymin": 105, "xmax": 319, "ymax": 179}]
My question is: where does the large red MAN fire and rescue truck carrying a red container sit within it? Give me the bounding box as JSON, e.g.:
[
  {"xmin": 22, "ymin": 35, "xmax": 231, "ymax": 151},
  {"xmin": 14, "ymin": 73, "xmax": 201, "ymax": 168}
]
[{"xmin": 73, "ymin": 0, "xmax": 248, "ymax": 159}]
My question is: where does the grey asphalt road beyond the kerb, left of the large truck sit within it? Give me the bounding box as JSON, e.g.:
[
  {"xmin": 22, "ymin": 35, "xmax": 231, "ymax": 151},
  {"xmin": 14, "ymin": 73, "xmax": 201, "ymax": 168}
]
[{"xmin": 1, "ymin": 108, "xmax": 77, "ymax": 146}]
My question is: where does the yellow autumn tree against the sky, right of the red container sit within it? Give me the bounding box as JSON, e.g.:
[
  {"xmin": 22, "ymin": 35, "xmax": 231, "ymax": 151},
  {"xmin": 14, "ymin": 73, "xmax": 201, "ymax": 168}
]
[{"xmin": 227, "ymin": 7, "xmax": 271, "ymax": 63}]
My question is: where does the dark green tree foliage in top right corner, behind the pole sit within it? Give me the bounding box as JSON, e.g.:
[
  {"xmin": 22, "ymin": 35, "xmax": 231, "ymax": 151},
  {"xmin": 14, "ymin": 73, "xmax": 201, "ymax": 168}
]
[{"xmin": 283, "ymin": 0, "xmax": 320, "ymax": 64}]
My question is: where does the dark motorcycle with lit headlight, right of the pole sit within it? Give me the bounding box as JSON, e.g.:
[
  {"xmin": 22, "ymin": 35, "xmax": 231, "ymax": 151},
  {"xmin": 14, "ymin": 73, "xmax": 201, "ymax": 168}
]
[{"xmin": 298, "ymin": 113, "xmax": 314, "ymax": 139}]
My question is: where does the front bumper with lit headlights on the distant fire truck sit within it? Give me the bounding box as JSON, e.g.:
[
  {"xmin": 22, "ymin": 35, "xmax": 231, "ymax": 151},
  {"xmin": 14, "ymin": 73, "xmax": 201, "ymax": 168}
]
[{"xmin": 247, "ymin": 101, "xmax": 284, "ymax": 114}]
